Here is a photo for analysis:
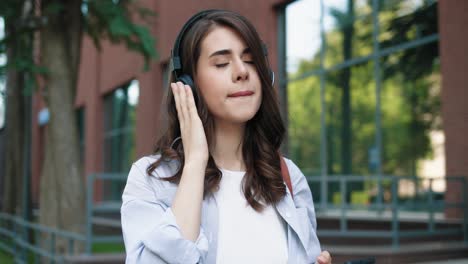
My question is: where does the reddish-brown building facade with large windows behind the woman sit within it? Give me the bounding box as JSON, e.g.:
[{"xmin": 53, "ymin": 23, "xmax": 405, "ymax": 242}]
[{"xmin": 27, "ymin": 0, "xmax": 468, "ymax": 217}]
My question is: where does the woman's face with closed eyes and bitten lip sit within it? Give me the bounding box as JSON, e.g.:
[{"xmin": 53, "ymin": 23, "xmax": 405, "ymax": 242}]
[{"xmin": 195, "ymin": 26, "xmax": 262, "ymax": 123}]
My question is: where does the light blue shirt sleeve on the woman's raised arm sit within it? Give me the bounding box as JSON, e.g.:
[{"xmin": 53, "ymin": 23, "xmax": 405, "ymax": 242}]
[{"xmin": 121, "ymin": 162, "xmax": 208, "ymax": 264}]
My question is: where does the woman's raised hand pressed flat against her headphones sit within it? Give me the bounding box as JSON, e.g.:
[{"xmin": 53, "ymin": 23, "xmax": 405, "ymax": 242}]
[{"xmin": 171, "ymin": 82, "xmax": 208, "ymax": 164}]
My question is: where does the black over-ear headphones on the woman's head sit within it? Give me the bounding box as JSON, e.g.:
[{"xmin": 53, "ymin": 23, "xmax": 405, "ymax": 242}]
[{"xmin": 169, "ymin": 9, "xmax": 275, "ymax": 102}]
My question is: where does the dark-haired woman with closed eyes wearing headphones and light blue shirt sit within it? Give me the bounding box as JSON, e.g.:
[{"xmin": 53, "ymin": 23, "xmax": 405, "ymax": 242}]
[{"xmin": 121, "ymin": 10, "xmax": 331, "ymax": 263}]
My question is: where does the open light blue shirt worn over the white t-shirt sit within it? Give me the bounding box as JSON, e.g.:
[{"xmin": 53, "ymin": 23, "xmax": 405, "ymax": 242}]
[{"xmin": 121, "ymin": 156, "xmax": 321, "ymax": 264}]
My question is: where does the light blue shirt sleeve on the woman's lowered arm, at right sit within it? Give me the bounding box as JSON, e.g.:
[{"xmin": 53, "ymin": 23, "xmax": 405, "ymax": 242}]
[{"xmin": 288, "ymin": 160, "xmax": 321, "ymax": 263}]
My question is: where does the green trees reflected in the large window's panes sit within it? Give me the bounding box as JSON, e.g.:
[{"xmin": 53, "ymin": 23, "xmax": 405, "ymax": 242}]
[{"xmin": 288, "ymin": 2, "xmax": 440, "ymax": 183}]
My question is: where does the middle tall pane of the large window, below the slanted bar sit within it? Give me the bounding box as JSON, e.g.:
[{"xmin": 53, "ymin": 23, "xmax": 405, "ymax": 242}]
[{"xmin": 325, "ymin": 62, "xmax": 376, "ymax": 175}]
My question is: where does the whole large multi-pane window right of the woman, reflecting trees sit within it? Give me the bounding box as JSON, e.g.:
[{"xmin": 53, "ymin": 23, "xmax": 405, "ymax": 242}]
[{"xmin": 280, "ymin": 0, "xmax": 445, "ymax": 203}]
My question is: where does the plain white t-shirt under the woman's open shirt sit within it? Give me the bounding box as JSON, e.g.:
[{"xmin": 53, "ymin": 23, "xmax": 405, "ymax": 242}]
[{"xmin": 215, "ymin": 169, "xmax": 288, "ymax": 264}]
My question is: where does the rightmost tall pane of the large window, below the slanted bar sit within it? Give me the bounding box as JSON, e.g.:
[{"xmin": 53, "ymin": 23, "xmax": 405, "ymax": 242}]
[{"xmin": 381, "ymin": 45, "xmax": 443, "ymax": 176}]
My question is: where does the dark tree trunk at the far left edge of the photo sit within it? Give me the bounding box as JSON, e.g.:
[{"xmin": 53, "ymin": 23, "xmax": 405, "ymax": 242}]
[{"xmin": 0, "ymin": 0, "xmax": 35, "ymax": 220}]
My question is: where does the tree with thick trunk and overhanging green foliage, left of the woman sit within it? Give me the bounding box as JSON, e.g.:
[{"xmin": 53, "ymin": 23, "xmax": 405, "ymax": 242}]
[{"xmin": 0, "ymin": 0, "xmax": 156, "ymax": 253}]
